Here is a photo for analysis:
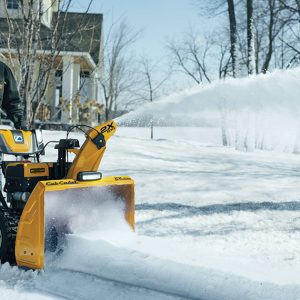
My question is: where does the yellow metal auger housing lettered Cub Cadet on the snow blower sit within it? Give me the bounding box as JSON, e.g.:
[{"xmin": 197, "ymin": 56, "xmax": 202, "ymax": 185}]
[{"xmin": 15, "ymin": 176, "xmax": 134, "ymax": 269}]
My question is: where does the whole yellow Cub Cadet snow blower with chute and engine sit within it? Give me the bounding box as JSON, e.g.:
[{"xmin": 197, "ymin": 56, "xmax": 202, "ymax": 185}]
[{"xmin": 0, "ymin": 121, "xmax": 134, "ymax": 269}]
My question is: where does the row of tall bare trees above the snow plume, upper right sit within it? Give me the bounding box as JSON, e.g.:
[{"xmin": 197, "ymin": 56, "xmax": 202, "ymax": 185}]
[{"xmin": 168, "ymin": 0, "xmax": 300, "ymax": 84}]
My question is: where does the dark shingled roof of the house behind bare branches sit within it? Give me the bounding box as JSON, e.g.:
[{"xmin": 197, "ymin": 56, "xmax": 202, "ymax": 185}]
[{"xmin": 0, "ymin": 12, "xmax": 103, "ymax": 64}]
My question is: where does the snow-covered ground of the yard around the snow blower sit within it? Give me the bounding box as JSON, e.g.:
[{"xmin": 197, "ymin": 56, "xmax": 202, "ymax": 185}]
[{"xmin": 0, "ymin": 127, "xmax": 300, "ymax": 300}]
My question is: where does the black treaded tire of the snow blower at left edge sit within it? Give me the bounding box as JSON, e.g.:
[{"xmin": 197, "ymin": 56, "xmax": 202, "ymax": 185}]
[{"xmin": 0, "ymin": 208, "xmax": 19, "ymax": 265}]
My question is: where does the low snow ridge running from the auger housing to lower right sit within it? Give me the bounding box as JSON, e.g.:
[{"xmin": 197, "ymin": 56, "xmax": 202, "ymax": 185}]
[{"xmin": 50, "ymin": 237, "xmax": 300, "ymax": 300}]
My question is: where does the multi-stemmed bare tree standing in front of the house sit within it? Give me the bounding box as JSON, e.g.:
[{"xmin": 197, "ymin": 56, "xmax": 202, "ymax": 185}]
[{"xmin": 1, "ymin": 0, "xmax": 93, "ymax": 126}]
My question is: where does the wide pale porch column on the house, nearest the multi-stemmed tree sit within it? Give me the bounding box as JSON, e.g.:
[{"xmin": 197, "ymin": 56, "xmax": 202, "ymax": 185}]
[{"xmin": 61, "ymin": 56, "xmax": 74, "ymax": 124}]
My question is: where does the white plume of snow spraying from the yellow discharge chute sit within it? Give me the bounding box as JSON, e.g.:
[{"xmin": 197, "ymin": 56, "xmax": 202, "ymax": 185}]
[{"xmin": 117, "ymin": 68, "xmax": 300, "ymax": 152}]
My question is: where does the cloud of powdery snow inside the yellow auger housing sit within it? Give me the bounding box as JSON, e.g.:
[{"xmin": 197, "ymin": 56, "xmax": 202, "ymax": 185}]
[{"xmin": 45, "ymin": 187, "xmax": 129, "ymax": 238}]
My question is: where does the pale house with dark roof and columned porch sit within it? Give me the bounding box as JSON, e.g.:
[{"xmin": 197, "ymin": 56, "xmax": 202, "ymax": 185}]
[{"xmin": 0, "ymin": 0, "xmax": 103, "ymax": 125}]
